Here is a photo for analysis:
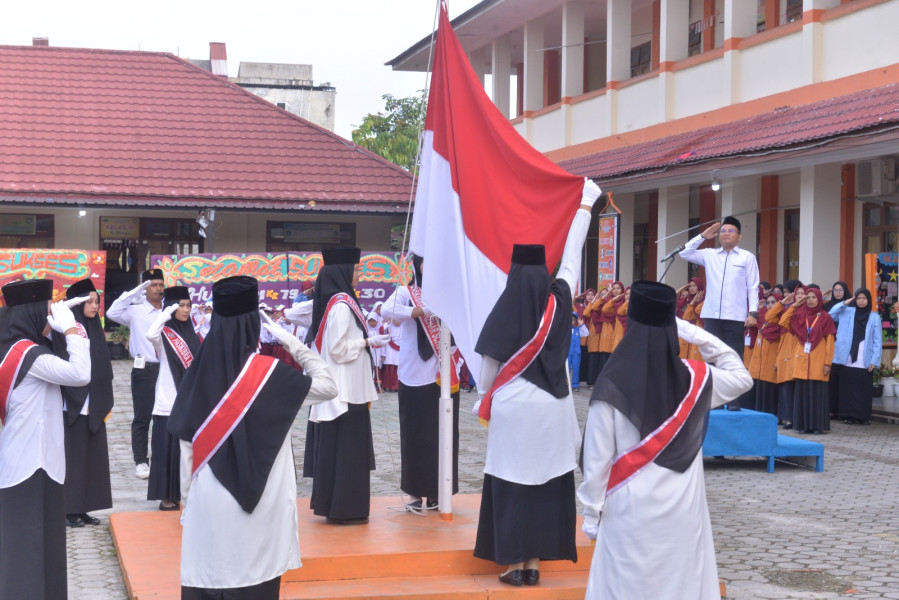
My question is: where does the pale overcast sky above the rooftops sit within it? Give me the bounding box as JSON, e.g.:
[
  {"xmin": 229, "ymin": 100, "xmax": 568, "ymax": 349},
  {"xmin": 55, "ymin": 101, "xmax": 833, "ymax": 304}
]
[{"xmin": 0, "ymin": 0, "xmax": 479, "ymax": 138}]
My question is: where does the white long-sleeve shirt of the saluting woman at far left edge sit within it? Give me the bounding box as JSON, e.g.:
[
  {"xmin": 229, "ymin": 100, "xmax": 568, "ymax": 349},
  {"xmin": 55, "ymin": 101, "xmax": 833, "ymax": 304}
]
[{"xmin": 0, "ymin": 334, "xmax": 91, "ymax": 488}]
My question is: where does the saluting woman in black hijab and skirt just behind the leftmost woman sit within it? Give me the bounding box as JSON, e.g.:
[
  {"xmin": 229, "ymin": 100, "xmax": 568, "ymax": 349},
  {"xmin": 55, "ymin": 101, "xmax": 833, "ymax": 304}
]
[{"xmin": 53, "ymin": 279, "xmax": 113, "ymax": 527}]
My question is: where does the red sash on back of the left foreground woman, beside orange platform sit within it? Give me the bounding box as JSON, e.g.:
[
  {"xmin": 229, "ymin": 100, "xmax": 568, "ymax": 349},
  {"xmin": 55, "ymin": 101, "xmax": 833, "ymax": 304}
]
[{"xmin": 191, "ymin": 354, "xmax": 278, "ymax": 478}]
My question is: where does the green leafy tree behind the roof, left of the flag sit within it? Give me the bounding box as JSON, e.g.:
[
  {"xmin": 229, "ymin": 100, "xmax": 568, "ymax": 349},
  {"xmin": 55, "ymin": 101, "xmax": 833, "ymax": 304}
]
[{"xmin": 353, "ymin": 90, "xmax": 428, "ymax": 171}]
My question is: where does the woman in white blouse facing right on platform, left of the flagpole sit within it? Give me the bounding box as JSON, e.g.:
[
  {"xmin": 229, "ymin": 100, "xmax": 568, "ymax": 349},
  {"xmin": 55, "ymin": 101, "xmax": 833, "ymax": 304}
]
[{"xmin": 303, "ymin": 248, "xmax": 387, "ymax": 524}]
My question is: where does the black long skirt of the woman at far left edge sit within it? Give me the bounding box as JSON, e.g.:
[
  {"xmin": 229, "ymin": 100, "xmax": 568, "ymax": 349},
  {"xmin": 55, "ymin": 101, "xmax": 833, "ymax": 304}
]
[{"xmin": 0, "ymin": 469, "xmax": 68, "ymax": 600}]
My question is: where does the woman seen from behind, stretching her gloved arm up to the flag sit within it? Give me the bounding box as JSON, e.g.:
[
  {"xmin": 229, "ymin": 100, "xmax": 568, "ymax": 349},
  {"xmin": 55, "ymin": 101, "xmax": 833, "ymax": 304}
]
[{"xmin": 474, "ymin": 180, "xmax": 601, "ymax": 587}]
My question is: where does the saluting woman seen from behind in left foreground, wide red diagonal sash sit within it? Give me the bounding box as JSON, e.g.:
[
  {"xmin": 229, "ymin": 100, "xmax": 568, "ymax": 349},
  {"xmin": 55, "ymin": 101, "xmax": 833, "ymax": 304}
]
[{"xmin": 168, "ymin": 276, "xmax": 337, "ymax": 600}]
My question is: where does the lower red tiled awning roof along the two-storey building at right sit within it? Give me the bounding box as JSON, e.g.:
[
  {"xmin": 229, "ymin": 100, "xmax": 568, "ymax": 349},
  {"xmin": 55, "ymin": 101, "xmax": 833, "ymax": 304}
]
[{"xmin": 559, "ymin": 84, "xmax": 899, "ymax": 180}]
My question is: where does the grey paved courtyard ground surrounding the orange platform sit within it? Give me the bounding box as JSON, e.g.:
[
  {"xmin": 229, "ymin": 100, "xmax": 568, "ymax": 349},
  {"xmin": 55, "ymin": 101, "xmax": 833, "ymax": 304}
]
[{"xmin": 68, "ymin": 361, "xmax": 899, "ymax": 600}]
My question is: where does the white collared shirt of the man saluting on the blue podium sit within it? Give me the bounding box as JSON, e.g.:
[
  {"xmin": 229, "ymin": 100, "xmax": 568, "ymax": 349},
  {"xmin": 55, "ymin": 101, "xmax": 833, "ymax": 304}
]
[{"xmin": 680, "ymin": 234, "xmax": 759, "ymax": 322}]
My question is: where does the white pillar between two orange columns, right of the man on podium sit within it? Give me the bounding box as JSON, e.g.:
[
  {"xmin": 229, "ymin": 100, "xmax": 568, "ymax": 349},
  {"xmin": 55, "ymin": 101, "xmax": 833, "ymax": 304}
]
[{"xmin": 799, "ymin": 164, "xmax": 841, "ymax": 289}]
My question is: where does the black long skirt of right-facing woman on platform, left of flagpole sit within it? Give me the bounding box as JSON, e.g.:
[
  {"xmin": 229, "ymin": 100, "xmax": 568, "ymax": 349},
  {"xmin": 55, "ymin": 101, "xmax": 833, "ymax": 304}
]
[{"xmin": 303, "ymin": 404, "xmax": 375, "ymax": 520}]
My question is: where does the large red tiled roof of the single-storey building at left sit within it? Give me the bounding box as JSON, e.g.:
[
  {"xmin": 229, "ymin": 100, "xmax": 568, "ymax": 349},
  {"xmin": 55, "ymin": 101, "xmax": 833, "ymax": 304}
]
[{"xmin": 0, "ymin": 46, "xmax": 412, "ymax": 212}]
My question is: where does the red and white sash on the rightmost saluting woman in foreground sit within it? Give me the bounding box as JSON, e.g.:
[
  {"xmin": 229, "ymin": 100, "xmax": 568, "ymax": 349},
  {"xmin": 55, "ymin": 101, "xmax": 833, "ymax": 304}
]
[{"xmin": 606, "ymin": 360, "xmax": 709, "ymax": 496}]
